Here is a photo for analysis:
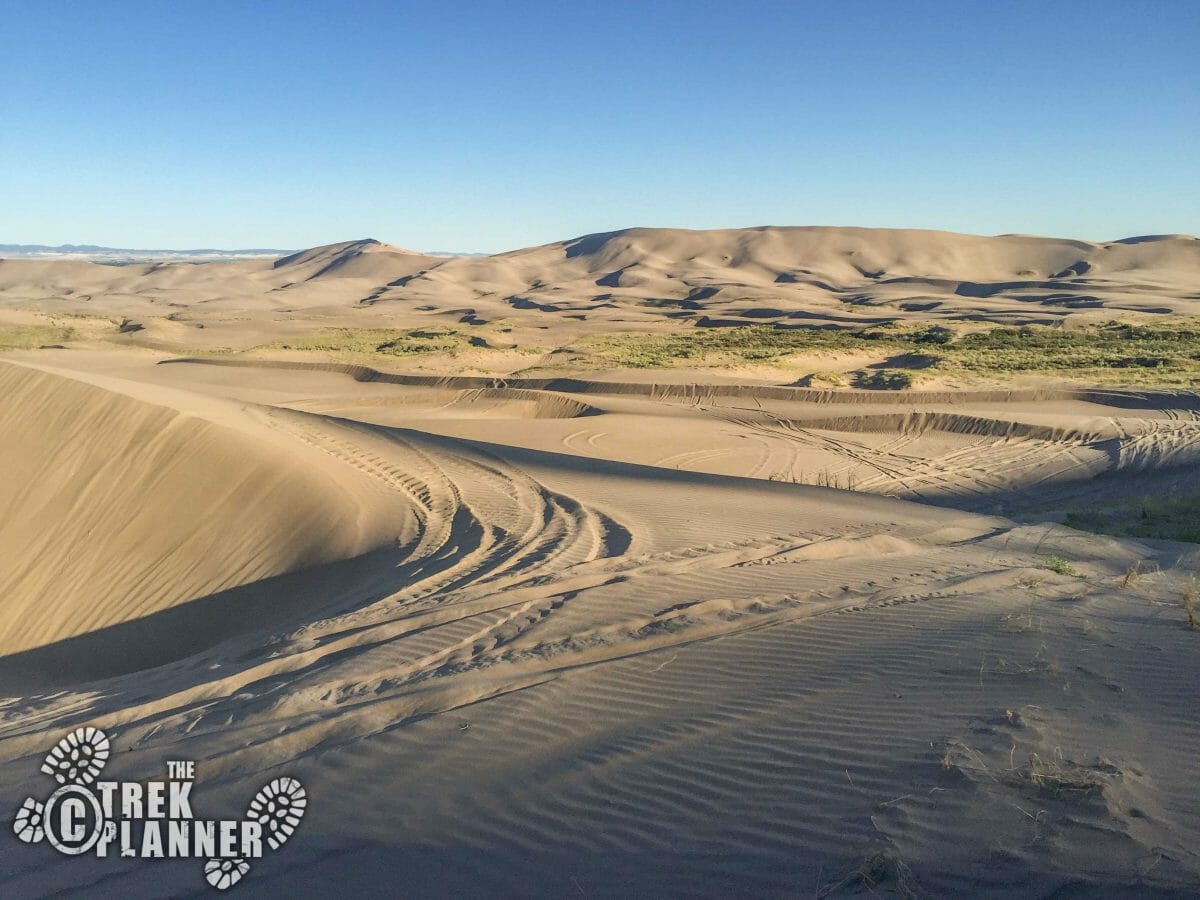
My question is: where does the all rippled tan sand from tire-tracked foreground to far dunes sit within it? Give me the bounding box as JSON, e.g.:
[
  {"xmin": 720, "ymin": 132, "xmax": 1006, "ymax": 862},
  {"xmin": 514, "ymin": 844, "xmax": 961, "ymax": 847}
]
[{"xmin": 0, "ymin": 229, "xmax": 1200, "ymax": 898}]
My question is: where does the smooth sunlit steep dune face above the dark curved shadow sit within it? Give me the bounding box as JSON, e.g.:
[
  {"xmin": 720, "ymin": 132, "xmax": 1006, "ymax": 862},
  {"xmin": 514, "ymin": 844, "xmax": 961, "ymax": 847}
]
[{"xmin": 0, "ymin": 364, "xmax": 412, "ymax": 654}]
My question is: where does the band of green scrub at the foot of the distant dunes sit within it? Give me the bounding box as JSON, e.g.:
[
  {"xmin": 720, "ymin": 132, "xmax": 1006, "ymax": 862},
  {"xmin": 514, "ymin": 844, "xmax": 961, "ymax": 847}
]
[{"xmin": 250, "ymin": 318, "xmax": 1200, "ymax": 390}]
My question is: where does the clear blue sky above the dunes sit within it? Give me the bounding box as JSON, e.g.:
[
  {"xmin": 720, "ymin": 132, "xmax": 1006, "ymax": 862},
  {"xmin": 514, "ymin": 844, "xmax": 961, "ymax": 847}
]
[{"xmin": 0, "ymin": 0, "xmax": 1200, "ymax": 251}]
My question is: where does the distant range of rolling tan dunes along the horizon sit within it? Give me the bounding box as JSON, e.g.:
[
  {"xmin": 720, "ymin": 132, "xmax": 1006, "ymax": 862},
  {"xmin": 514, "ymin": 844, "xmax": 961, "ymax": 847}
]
[{"xmin": 0, "ymin": 228, "xmax": 1200, "ymax": 341}]
